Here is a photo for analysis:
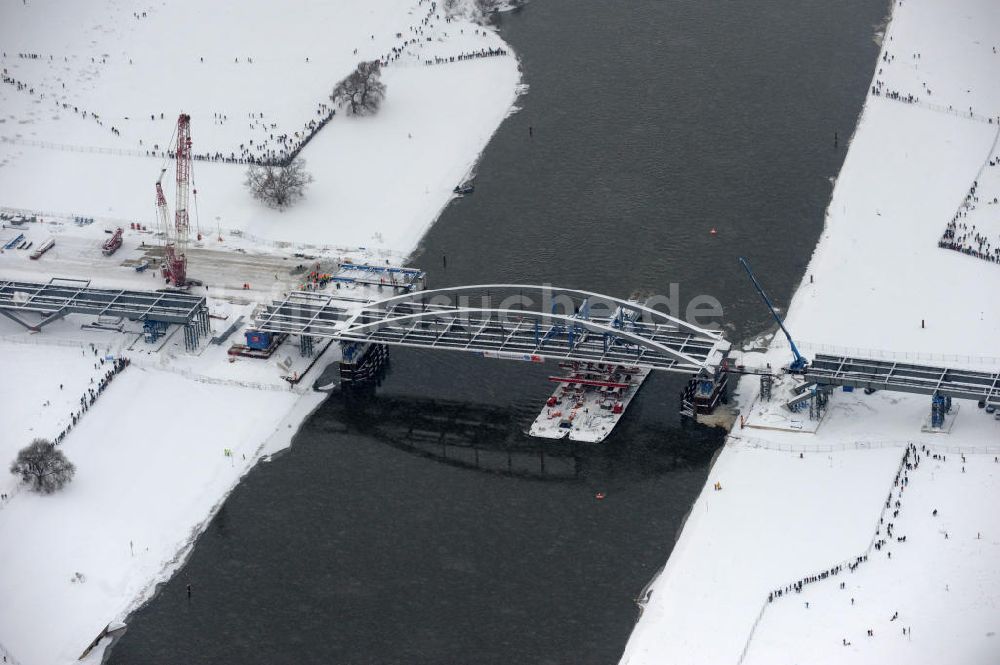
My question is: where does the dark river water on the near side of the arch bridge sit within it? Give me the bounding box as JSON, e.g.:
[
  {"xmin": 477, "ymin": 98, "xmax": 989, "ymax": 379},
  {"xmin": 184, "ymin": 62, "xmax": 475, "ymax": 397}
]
[{"xmin": 110, "ymin": 368, "xmax": 720, "ymax": 665}]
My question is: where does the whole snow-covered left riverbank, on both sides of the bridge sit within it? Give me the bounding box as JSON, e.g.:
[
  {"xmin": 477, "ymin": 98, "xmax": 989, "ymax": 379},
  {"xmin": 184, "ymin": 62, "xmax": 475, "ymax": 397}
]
[{"xmin": 0, "ymin": 0, "xmax": 520, "ymax": 665}]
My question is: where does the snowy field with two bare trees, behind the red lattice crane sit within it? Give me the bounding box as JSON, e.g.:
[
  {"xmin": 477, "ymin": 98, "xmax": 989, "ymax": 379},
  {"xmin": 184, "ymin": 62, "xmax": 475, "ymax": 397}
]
[{"xmin": 0, "ymin": 0, "xmax": 519, "ymax": 251}]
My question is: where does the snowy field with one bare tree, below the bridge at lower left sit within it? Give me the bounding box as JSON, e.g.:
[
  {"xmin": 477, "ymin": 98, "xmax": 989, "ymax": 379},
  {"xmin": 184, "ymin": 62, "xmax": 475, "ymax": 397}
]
[{"xmin": 0, "ymin": 345, "xmax": 311, "ymax": 663}]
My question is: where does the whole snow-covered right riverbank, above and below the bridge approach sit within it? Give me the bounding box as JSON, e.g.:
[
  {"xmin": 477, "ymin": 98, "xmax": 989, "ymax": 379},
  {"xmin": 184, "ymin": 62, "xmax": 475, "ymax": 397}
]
[{"xmin": 622, "ymin": 0, "xmax": 1000, "ymax": 665}]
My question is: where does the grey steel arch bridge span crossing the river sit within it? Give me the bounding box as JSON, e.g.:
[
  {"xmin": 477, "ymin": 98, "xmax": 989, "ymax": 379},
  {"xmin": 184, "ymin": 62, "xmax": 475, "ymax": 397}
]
[{"xmin": 254, "ymin": 284, "xmax": 730, "ymax": 374}]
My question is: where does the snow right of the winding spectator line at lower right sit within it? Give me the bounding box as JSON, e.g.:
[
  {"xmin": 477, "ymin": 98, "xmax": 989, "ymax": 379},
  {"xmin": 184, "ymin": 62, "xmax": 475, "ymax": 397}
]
[{"xmin": 745, "ymin": 453, "xmax": 1000, "ymax": 663}]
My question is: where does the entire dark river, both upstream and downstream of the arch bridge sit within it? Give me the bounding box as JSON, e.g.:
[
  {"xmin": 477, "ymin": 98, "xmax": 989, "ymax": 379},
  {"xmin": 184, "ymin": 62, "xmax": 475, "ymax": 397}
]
[{"xmin": 110, "ymin": 0, "xmax": 886, "ymax": 665}]
